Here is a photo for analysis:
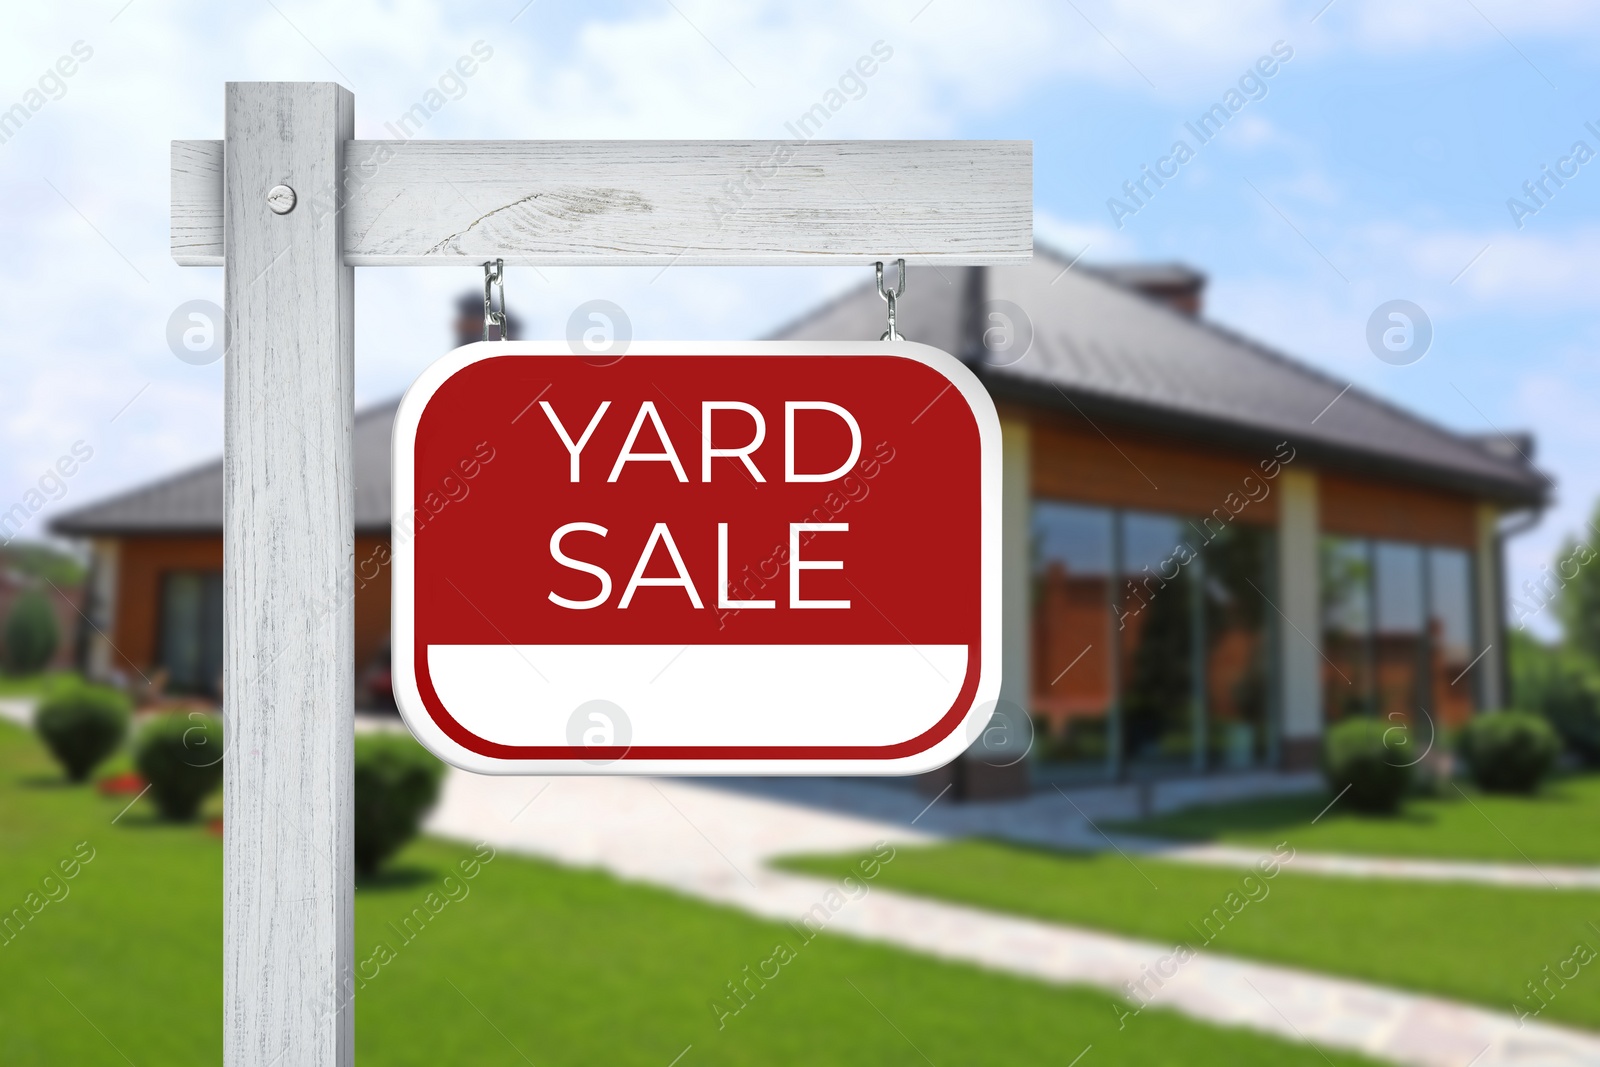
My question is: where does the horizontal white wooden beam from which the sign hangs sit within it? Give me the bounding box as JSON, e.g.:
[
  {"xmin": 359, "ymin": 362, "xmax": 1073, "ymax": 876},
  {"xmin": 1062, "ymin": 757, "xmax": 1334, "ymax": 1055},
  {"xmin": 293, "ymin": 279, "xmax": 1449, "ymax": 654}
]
[{"xmin": 171, "ymin": 141, "xmax": 1034, "ymax": 267}]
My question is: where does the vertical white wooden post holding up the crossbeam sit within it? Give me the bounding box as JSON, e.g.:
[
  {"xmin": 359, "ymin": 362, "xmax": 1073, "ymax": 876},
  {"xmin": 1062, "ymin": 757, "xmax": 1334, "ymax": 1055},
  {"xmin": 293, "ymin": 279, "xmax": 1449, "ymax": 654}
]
[{"xmin": 222, "ymin": 83, "xmax": 355, "ymax": 1067}]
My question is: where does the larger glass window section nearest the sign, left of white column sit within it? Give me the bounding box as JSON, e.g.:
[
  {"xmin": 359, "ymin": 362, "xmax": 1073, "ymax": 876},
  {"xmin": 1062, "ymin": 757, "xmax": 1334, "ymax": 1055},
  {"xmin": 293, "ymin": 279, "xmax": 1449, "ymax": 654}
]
[{"xmin": 1032, "ymin": 501, "xmax": 1275, "ymax": 774}]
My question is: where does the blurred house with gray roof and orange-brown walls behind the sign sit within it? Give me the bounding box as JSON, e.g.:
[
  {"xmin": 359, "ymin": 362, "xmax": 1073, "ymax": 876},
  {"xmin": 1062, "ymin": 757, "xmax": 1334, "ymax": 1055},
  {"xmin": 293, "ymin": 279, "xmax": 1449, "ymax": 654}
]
[{"xmin": 53, "ymin": 250, "xmax": 1549, "ymax": 795}]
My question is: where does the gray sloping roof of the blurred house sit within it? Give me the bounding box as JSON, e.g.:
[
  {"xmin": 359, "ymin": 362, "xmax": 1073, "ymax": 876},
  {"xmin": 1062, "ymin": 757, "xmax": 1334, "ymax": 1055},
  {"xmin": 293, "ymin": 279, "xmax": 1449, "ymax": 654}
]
[{"xmin": 51, "ymin": 246, "xmax": 1549, "ymax": 536}]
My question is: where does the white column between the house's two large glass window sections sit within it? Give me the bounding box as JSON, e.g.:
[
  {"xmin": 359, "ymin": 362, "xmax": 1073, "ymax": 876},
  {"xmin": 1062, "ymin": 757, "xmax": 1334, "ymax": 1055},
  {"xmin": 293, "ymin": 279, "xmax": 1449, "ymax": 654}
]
[{"xmin": 1277, "ymin": 467, "xmax": 1322, "ymax": 766}]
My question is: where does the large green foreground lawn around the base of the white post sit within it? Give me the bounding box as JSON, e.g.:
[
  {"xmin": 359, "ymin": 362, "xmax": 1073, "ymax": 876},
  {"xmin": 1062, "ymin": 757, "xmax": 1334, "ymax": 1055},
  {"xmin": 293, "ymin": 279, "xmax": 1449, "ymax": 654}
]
[{"xmin": 0, "ymin": 723, "xmax": 1365, "ymax": 1067}]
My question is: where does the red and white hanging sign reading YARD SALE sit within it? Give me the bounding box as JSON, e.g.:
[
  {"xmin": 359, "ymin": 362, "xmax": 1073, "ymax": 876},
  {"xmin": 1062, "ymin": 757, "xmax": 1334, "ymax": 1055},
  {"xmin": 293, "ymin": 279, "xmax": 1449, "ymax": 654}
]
[{"xmin": 392, "ymin": 341, "xmax": 1000, "ymax": 774}]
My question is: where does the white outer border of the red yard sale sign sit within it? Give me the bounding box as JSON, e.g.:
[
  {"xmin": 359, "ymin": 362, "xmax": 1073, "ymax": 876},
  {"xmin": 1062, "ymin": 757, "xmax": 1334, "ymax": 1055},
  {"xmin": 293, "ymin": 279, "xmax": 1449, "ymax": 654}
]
[{"xmin": 389, "ymin": 341, "xmax": 1002, "ymax": 776}]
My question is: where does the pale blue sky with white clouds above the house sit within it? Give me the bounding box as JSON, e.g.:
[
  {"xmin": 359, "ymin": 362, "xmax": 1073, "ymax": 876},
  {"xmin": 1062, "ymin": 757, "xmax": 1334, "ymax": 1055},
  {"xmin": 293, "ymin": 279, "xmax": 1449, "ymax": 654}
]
[{"xmin": 0, "ymin": 0, "xmax": 1600, "ymax": 632}]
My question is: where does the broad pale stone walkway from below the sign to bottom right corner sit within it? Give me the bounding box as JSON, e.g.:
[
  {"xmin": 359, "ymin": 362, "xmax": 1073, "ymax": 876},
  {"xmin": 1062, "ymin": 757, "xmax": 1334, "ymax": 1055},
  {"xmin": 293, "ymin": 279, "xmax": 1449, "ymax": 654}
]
[{"xmin": 427, "ymin": 771, "xmax": 1600, "ymax": 1067}]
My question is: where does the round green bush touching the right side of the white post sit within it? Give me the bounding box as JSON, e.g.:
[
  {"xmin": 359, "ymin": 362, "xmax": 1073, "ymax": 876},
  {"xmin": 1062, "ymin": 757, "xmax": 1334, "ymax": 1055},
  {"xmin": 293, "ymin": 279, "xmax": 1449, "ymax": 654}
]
[{"xmin": 355, "ymin": 734, "xmax": 445, "ymax": 875}]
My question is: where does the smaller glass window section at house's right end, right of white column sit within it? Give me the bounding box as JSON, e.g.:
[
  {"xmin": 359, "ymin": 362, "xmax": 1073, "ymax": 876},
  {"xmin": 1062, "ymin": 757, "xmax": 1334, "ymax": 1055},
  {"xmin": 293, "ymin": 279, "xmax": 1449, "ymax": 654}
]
[{"xmin": 1322, "ymin": 536, "xmax": 1477, "ymax": 726}]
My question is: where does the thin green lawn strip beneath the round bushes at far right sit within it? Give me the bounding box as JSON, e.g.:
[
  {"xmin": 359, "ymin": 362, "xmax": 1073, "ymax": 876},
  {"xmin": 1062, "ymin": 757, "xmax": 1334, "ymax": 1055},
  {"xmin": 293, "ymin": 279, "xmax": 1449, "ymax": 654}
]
[{"xmin": 1107, "ymin": 774, "xmax": 1600, "ymax": 864}]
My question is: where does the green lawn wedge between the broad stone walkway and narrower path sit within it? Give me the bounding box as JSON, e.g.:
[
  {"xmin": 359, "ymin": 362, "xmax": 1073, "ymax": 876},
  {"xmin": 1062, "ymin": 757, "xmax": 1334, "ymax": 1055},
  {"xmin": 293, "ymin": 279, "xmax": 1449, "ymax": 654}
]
[{"xmin": 784, "ymin": 844, "xmax": 1600, "ymax": 1029}]
